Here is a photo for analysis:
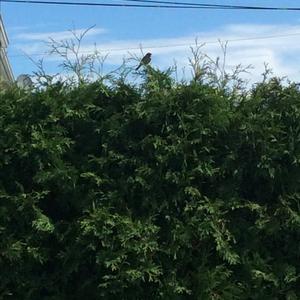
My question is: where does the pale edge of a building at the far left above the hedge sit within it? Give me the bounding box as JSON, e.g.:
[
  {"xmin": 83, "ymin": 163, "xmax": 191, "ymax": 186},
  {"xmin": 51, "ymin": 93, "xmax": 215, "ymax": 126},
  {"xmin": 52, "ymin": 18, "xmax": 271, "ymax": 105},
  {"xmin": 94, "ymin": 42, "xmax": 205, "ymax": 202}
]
[{"xmin": 0, "ymin": 15, "xmax": 14, "ymax": 81}]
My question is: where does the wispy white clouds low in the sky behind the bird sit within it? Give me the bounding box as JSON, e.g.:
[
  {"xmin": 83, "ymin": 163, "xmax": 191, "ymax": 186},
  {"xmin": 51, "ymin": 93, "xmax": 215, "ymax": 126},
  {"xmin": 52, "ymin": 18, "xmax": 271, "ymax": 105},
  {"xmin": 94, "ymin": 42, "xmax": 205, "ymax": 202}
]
[{"xmin": 11, "ymin": 24, "xmax": 300, "ymax": 81}]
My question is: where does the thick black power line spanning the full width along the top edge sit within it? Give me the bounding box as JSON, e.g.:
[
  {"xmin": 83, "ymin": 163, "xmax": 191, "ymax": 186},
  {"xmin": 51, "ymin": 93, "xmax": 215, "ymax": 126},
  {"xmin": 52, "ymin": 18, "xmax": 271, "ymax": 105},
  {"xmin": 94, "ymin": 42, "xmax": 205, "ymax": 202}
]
[{"xmin": 2, "ymin": 0, "xmax": 300, "ymax": 11}]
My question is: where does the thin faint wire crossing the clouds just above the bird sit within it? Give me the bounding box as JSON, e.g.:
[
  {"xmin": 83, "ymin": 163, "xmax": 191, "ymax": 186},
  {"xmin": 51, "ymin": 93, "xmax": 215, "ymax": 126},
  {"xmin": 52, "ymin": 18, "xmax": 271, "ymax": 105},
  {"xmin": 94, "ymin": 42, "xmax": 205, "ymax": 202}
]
[{"xmin": 9, "ymin": 32, "xmax": 300, "ymax": 58}]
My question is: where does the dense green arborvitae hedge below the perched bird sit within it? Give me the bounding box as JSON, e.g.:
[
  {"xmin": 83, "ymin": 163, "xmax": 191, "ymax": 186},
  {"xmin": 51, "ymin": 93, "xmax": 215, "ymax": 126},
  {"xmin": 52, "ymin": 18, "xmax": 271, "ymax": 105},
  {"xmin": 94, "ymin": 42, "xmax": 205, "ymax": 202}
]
[{"xmin": 0, "ymin": 72, "xmax": 300, "ymax": 300}]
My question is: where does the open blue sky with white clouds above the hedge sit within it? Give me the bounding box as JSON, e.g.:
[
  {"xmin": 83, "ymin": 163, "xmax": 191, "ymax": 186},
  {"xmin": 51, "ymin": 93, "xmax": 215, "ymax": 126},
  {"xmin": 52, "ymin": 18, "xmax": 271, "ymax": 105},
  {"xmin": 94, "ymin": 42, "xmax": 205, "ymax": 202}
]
[{"xmin": 1, "ymin": 0, "xmax": 300, "ymax": 81}]
